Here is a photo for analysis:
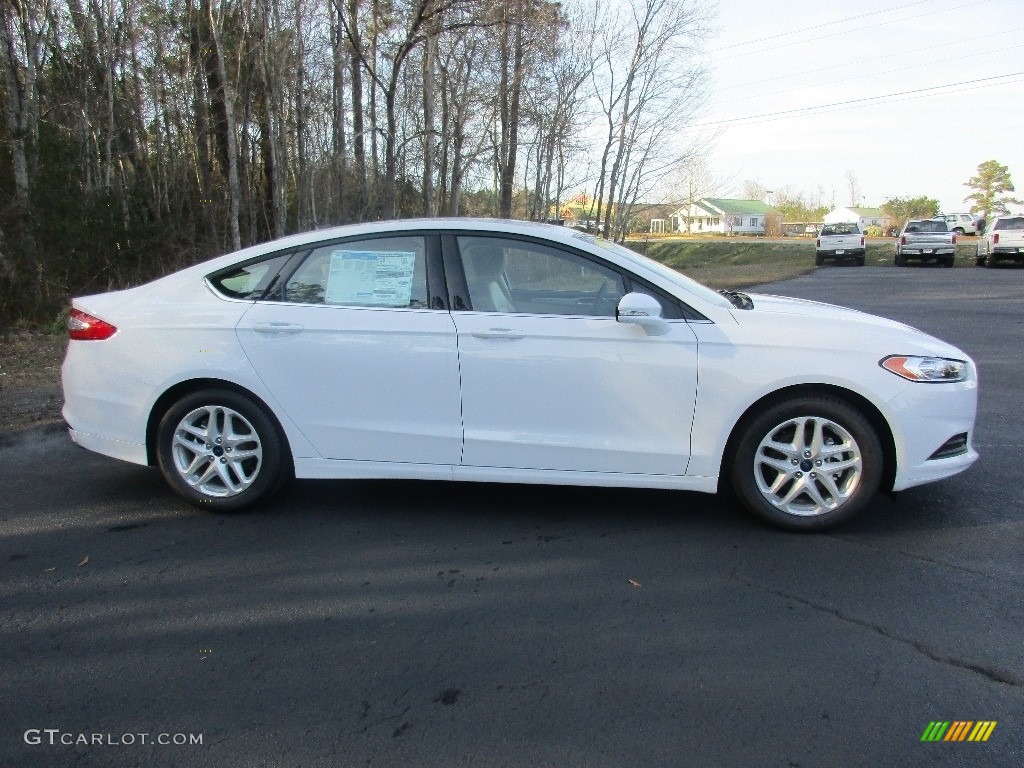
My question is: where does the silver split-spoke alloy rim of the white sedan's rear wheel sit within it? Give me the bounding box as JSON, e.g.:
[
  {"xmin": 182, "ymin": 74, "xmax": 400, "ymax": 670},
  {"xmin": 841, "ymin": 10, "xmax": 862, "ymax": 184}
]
[{"xmin": 171, "ymin": 406, "xmax": 263, "ymax": 499}]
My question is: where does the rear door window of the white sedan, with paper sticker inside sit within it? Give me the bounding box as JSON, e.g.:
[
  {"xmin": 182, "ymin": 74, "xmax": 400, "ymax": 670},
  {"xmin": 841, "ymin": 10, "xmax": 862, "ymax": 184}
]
[{"xmin": 284, "ymin": 236, "xmax": 427, "ymax": 309}]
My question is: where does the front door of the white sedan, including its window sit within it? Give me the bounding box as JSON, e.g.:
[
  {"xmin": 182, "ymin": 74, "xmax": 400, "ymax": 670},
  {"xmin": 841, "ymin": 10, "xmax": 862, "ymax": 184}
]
[{"xmin": 452, "ymin": 237, "xmax": 697, "ymax": 475}]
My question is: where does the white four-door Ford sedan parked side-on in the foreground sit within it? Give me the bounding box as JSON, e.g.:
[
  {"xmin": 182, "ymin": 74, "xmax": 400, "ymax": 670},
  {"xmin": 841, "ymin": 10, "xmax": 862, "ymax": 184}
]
[{"xmin": 63, "ymin": 219, "xmax": 977, "ymax": 529}]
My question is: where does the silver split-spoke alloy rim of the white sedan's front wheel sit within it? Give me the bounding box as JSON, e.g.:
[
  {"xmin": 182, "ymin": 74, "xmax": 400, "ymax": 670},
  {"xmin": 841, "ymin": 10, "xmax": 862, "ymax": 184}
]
[{"xmin": 754, "ymin": 416, "xmax": 864, "ymax": 517}]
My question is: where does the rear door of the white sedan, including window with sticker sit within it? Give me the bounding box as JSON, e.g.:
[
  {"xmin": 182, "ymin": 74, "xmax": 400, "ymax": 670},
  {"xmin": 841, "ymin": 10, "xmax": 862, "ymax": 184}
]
[{"xmin": 238, "ymin": 232, "xmax": 462, "ymax": 464}]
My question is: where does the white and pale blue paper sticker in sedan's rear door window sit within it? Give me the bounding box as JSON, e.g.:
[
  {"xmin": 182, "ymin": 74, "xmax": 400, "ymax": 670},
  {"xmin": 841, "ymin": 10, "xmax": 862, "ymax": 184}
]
[{"xmin": 325, "ymin": 251, "xmax": 416, "ymax": 307}]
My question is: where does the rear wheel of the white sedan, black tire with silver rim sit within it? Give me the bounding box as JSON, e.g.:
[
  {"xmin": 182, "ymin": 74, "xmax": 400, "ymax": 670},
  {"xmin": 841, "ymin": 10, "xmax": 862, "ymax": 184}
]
[{"xmin": 157, "ymin": 389, "xmax": 292, "ymax": 512}]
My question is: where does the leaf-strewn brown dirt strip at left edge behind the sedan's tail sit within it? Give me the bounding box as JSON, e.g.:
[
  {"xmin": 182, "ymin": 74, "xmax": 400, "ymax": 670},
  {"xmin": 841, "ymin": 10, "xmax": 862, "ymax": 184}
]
[{"xmin": 0, "ymin": 331, "xmax": 68, "ymax": 442}]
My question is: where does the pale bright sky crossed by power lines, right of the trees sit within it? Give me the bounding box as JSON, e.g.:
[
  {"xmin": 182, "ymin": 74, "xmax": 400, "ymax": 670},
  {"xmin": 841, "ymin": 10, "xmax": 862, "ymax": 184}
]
[{"xmin": 696, "ymin": 0, "xmax": 1024, "ymax": 213}]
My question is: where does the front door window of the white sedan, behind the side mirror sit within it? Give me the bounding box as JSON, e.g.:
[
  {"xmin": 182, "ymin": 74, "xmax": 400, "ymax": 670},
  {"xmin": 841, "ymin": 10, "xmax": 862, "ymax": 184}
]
[{"xmin": 459, "ymin": 237, "xmax": 626, "ymax": 317}]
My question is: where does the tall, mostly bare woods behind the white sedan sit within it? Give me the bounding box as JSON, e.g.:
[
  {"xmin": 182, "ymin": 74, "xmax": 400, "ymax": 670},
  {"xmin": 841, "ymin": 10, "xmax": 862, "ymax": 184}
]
[{"xmin": 0, "ymin": 0, "xmax": 709, "ymax": 325}]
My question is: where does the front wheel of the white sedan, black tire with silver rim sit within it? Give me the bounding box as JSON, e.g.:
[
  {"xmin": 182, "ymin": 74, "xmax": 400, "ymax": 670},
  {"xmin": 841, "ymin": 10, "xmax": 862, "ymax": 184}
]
[{"xmin": 730, "ymin": 395, "xmax": 884, "ymax": 531}]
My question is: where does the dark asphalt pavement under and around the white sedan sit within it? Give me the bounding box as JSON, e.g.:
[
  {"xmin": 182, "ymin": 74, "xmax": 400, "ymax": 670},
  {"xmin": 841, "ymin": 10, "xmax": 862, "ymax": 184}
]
[{"xmin": 0, "ymin": 267, "xmax": 1024, "ymax": 768}]
